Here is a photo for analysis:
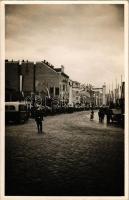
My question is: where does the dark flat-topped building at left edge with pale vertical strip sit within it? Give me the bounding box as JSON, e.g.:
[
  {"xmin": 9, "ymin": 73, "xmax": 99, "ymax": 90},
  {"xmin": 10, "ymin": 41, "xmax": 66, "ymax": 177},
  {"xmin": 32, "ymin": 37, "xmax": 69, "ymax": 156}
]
[{"xmin": 5, "ymin": 60, "xmax": 35, "ymax": 101}]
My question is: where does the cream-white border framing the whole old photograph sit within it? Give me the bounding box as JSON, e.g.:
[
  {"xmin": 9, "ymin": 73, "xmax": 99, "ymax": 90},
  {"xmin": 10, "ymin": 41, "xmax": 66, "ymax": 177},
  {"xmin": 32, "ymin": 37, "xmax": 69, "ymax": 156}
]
[{"xmin": 0, "ymin": 0, "xmax": 129, "ymax": 200}]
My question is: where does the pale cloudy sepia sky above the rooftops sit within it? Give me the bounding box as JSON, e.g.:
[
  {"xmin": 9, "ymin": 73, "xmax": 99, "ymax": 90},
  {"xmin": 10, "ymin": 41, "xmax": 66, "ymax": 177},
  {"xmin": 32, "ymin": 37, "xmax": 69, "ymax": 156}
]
[{"xmin": 5, "ymin": 4, "xmax": 124, "ymax": 87}]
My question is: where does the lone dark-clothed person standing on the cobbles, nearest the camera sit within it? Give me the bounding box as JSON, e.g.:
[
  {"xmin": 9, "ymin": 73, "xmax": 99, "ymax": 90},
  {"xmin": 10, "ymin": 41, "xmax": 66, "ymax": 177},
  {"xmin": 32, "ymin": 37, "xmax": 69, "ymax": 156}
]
[{"xmin": 34, "ymin": 106, "xmax": 43, "ymax": 133}]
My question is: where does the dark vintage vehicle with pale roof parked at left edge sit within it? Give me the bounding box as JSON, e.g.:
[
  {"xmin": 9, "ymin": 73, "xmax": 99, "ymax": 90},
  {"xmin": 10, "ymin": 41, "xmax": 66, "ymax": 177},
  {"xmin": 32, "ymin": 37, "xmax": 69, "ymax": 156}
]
[{"xmin": 5, "ymin": 101, "xmax": 29, "ymax": 123}]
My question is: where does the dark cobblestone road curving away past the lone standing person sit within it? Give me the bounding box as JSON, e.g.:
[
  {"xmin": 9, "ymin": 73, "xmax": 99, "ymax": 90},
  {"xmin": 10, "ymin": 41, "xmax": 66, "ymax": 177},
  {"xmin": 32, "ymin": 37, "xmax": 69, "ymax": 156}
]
[{"xmin": 6, "ymin": 111, "xmax": 124, "ymax": 196}]
